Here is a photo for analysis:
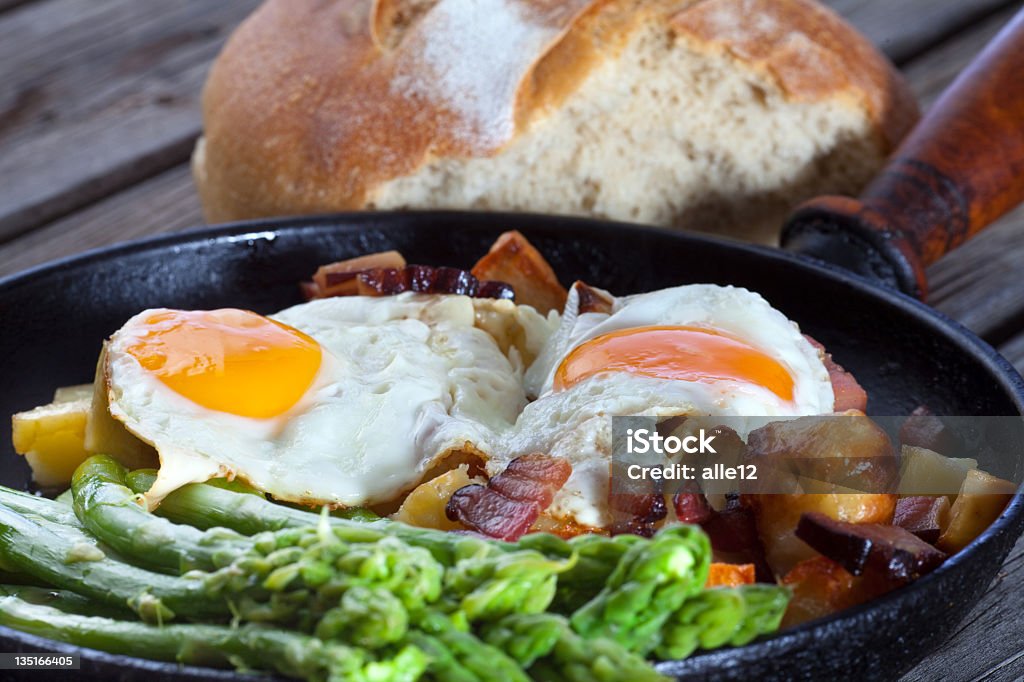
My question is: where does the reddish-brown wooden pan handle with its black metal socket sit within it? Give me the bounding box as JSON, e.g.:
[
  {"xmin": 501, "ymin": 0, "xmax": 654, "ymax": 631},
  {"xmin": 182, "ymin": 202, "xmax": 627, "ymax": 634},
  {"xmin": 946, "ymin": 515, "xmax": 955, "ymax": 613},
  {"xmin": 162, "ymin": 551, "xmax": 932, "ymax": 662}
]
[{"xmin": 782, "ymin": 10, "xmax": 1024, "ymax": 299}]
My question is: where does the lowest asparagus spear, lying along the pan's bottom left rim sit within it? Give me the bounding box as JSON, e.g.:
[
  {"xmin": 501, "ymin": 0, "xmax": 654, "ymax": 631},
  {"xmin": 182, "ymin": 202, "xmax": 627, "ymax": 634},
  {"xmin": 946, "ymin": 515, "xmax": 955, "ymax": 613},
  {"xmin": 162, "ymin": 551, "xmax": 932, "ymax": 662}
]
[{"xmin": 0, "ymin": 596, "xmax": 427, "ymax": 682}]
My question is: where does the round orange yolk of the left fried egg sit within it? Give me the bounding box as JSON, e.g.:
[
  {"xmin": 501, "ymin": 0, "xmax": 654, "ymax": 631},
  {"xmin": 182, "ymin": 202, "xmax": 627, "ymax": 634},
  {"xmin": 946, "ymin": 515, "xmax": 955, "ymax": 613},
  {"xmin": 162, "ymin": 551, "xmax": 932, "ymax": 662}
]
[{"xmin": 128, "ymin": 308, "xmax": 322, "ymax": 419}]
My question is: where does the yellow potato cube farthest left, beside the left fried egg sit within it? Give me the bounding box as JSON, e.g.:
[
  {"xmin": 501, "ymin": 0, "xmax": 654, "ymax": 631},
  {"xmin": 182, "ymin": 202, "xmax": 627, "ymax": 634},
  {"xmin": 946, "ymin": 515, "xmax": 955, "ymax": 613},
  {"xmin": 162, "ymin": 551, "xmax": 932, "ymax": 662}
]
[{"xmin": 11, "ymin": 396, "xmax": 92, "ymax": 486}]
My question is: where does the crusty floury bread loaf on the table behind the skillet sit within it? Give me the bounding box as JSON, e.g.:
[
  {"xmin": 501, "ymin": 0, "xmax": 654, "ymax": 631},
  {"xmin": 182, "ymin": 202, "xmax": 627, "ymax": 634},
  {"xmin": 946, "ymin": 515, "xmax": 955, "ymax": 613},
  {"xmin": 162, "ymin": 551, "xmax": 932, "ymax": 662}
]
[{"xmin": 194, "ymin": 0, "xmax": 918, "ymax": 241}]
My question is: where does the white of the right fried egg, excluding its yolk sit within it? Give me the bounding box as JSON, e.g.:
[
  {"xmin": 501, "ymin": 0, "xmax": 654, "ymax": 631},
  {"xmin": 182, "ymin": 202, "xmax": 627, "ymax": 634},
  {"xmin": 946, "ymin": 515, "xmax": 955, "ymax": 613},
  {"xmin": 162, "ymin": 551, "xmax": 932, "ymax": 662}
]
[{"xmin": 497, "ymin": 285, "xmax": 835, "ymax": 527}]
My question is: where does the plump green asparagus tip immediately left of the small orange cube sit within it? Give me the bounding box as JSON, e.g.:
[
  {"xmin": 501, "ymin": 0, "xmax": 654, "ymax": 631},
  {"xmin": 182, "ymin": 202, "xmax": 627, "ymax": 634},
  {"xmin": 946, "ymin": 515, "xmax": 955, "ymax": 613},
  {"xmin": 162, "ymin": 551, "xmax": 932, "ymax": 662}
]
[{"xmin": 571, "ymin": 525, "xmax": 711, "ymax": 653}]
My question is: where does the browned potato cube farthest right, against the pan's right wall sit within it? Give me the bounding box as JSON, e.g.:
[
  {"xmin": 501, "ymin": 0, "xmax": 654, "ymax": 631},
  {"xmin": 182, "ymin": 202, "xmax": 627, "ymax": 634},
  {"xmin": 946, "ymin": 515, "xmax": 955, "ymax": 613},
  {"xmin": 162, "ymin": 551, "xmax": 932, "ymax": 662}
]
[{"xmin": 936, "ymin": 469, "xmax": 1017, "ymax": 554}]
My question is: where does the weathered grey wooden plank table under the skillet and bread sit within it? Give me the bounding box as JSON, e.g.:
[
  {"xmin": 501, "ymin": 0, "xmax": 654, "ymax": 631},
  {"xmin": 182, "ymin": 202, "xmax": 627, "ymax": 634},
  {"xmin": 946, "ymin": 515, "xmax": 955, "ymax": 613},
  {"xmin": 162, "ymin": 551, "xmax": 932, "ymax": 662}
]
[{"xmin": 0, "ymin": 0, "xmax": 1024, "ymax": 681}]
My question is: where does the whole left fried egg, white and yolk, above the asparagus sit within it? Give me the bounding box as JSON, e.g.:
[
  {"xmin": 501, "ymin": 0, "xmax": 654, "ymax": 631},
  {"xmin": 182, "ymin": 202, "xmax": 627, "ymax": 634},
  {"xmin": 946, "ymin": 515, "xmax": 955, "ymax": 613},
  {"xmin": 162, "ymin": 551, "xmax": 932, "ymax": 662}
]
[{"xmin": 104, "ymin": 294, "xmax": 536, "ymax": 506}]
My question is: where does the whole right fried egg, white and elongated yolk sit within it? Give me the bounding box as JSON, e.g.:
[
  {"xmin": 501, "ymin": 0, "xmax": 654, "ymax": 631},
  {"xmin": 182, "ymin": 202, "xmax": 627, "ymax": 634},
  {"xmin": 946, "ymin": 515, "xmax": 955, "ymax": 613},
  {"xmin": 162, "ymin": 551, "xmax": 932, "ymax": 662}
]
[{"xmin": 499, "ymin": 285, "xmax": 835, "ymax": 527}]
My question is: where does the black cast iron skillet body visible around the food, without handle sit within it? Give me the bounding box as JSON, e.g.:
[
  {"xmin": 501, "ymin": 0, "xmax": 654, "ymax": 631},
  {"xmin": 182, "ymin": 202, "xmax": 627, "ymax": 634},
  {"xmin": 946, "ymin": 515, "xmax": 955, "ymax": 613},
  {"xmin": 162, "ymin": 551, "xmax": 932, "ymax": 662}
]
[{"xmin": 0, "ymin": 213, "xmax": 1024, "ymax": 680}]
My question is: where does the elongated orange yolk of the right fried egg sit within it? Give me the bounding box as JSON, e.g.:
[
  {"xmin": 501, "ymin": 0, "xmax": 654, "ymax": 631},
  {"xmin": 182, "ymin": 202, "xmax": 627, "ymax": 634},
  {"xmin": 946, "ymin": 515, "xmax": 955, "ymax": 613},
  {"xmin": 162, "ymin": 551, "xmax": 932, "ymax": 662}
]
[{"xmin": 554, "ymin": 327, "xmax": 794, "ymax": 400}]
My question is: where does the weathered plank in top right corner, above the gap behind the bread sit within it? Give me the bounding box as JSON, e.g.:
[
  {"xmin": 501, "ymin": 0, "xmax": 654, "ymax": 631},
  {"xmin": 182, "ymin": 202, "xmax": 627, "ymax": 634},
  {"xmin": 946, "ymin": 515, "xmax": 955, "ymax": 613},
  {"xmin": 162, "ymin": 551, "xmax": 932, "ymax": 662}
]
[{"xmin": 824, "ymin": 0, "xmax": 1013, "ymax": 63}]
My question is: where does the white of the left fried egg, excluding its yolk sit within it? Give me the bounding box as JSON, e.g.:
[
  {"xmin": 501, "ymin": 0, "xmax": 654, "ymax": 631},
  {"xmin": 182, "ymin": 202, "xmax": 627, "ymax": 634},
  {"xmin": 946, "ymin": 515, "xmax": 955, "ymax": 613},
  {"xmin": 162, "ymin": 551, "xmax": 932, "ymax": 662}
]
[{"xmin": 106, "ymin": 294, "xmax": 525, "ymax": 506}]
